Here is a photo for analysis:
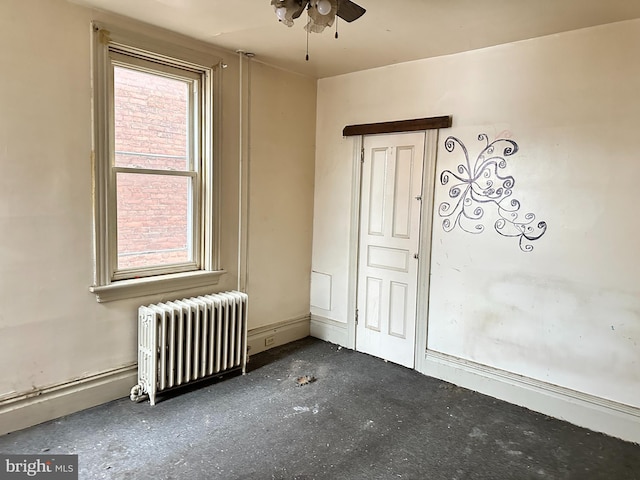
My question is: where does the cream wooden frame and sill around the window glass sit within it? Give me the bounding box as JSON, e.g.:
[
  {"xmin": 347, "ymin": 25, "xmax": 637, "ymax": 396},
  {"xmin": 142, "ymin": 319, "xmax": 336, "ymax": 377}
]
[{"xmin": 90, "ymin": 22, "xmax": 224, "ymax": 302}]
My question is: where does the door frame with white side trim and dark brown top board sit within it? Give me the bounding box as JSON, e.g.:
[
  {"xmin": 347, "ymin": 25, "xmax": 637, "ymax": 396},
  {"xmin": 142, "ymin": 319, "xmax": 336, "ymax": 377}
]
[{"xmin": 343, "ymin": 116, "xmax": 452, "ymax": 371}]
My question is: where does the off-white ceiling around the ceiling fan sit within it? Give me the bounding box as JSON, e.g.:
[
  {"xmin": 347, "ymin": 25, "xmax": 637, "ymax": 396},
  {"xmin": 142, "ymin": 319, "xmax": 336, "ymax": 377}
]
[{"xmin": 72, "ymin": 0, "xmax": 640, "ymax": 78}]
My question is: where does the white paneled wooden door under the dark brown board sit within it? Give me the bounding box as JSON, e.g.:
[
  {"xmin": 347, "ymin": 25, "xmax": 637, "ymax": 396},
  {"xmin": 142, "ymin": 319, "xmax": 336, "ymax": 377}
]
[{"xmin": 356, "ymin": 132, "xmax": 425, "ymax": 368}]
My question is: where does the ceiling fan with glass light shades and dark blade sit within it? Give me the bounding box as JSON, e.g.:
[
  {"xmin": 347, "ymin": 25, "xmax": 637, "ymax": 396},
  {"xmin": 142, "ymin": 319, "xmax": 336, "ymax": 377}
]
[{"xmin": 271, "ymin": 0, "xmax": 366, "ymax": 34}]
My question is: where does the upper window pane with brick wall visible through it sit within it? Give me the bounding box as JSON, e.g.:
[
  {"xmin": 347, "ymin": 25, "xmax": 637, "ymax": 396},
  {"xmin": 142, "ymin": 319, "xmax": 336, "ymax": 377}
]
[{"xmin": 114, "ymin": 66, "xmax": 189, "ymax": 170}]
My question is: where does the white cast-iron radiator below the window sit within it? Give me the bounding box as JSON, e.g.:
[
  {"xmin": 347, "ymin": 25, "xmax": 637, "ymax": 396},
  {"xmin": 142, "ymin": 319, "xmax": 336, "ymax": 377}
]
[{"xmin": 131, "ymin": 291, "xmax": 248, "ymax": 405}]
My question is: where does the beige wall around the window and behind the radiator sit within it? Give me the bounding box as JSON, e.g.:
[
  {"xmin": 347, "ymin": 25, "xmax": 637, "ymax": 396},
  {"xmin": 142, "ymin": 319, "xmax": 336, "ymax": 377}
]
[{"xmin": 0, "ymin": 0, "xmax": 315, "ymax": 433}]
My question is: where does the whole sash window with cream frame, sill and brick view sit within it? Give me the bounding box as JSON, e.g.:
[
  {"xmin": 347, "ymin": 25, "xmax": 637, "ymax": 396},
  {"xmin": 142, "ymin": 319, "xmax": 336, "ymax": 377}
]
[{"xmin": 91, "ymin": 24, "xmax": 222, "ymax": 301}]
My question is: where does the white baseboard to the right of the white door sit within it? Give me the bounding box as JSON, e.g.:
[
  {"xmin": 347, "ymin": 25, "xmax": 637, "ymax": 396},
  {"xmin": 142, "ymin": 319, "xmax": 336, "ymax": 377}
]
[{"xmin": 420, "ymin": 350, "xmax": 640, "ymax": 443}]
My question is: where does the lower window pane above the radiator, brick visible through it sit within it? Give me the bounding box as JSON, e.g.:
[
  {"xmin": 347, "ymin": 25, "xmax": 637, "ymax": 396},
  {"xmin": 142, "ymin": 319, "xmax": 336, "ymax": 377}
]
[{"xmin": 116, "ymin": 172, "xmax": 193, "ymax": 270}]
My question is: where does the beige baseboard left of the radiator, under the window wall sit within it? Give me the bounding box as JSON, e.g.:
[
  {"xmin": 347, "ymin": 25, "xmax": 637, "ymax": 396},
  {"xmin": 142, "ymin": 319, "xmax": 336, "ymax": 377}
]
[{"xmin": 0, "ymin": 365, "xmax": 138, "ymax": 435}]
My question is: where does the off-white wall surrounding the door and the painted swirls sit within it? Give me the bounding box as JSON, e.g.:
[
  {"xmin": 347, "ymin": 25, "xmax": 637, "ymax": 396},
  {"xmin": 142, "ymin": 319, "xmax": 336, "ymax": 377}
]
[{"xmin": 312, "ymin": 20, "xmax": 640, "ymax": 438}]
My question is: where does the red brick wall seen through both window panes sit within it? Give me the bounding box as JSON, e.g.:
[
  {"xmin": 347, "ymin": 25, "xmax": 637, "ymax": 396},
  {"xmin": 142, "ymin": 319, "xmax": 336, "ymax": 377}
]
[{"xmin": 114, "ymin": 67, "xmax": 192, "ymax": 269}]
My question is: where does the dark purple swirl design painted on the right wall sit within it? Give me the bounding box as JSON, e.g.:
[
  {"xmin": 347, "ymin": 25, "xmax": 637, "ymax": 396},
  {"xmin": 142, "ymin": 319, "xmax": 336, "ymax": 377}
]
[{"xmin": 438, "ymin": 133, "xmax": 547, "ymax": 252}]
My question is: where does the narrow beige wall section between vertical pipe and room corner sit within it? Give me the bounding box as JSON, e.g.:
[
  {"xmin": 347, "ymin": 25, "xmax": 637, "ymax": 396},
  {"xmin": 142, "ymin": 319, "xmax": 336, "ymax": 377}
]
[{"xmin": 247, "ymin": 62, "xmax": 316, "ymax": 327}]
